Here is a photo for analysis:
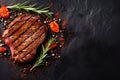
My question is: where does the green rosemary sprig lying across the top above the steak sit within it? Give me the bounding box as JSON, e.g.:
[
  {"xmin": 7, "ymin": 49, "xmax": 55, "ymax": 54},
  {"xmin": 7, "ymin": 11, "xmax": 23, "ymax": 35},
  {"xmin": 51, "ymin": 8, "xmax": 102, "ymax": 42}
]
[{"xmin": 7, "ymin": 1, "xmax": 53, "ymax": 17}]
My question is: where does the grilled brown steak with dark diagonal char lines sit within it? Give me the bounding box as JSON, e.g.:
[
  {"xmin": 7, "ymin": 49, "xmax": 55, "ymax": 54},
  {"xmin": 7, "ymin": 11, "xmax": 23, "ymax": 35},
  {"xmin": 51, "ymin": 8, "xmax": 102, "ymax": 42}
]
[{"xmin": 2, "ymin": 14, "xmax": 47, "ymax": 62}]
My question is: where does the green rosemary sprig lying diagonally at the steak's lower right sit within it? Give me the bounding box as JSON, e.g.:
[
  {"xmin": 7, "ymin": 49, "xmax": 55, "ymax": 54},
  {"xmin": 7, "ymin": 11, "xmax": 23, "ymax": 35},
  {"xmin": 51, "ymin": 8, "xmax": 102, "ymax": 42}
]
[{"xmin": 30, "ymin": 38, "xmax": 55, "ymax": 71}]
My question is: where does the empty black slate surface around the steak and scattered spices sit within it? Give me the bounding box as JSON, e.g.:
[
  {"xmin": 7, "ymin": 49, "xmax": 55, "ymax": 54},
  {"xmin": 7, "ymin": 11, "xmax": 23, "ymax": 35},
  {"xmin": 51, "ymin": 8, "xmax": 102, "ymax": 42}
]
[{"xmin": 0, "ymin": 0, "xmax": 120, "ymax": 80}]
